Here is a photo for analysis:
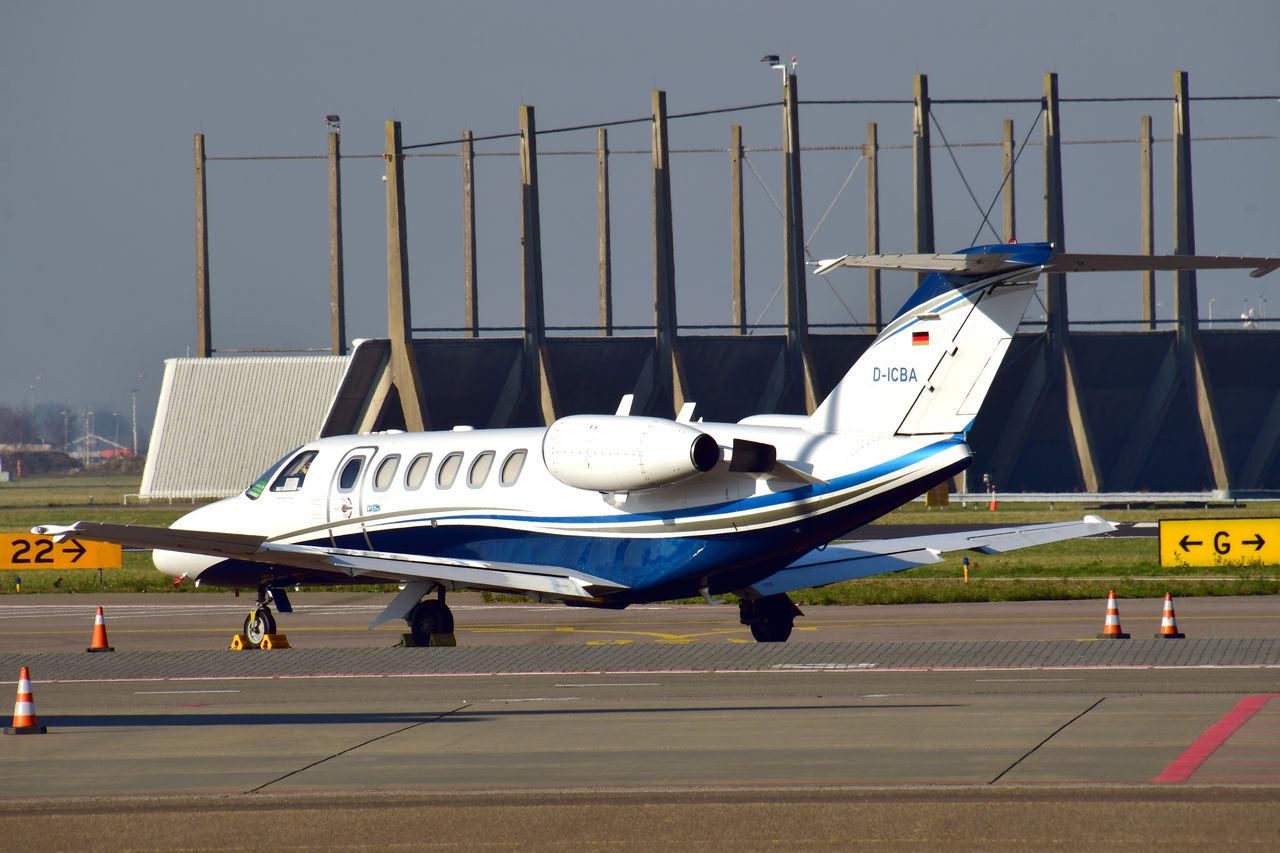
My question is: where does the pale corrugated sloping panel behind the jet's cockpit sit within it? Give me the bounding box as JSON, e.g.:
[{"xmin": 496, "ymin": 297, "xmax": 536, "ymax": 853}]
[{"xmin": 141, "ymin": 356, "xmax": 351, "ymax": 500}]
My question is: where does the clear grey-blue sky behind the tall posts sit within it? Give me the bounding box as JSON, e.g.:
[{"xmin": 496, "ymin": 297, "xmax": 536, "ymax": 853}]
[{"xmin": 0, "ymin": 0, "xmax": 1280, "ymax": 433}]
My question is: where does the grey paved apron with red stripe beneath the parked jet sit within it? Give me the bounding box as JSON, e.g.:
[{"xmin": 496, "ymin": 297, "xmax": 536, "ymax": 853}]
[{"xmin": 0, "ymin": 596, "xmax": 1280, "ymax": 849}]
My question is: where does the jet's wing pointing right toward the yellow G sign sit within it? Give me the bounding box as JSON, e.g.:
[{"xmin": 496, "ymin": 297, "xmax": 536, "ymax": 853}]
[{"xmin": 749, "ymin": 515, "xmax": 1116, "ymax": 596}]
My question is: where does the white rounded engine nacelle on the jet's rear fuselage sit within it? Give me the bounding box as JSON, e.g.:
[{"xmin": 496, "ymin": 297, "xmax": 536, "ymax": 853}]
[{"xmin": 543, "ymin": 415, "xmax": 721, "ymax": 492}]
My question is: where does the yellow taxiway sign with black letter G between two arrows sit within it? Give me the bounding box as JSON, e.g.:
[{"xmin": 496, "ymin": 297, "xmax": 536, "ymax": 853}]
[{"xmin": 1160, "ymin": 519, "xmax": 1280, "ymax": 567}]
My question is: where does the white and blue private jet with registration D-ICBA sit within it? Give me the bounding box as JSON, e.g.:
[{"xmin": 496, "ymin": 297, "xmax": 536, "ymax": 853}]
[{"xmin": 36, "ymin": 243, "xmax": 1280, "ymax": 637}]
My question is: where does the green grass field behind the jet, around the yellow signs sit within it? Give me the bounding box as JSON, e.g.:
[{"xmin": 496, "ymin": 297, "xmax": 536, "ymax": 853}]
[{"xmin": 0, "ymin": 473, "xmax": 1280, "ymax": 605}]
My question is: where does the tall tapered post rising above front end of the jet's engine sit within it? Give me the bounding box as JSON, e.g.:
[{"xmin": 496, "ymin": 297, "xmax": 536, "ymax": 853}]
[{"xmin": 520, "ymin": 106, "xmax": 557, "ymax": 425}]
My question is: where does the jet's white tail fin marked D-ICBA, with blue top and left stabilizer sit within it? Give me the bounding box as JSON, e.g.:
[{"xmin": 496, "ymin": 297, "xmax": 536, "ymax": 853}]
[{"xmin": 809, "ymin": 243, "xmax": 1052, "ymax": 435}]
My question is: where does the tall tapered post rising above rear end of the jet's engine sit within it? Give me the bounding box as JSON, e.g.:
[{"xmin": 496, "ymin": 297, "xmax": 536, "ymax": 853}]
[{"xmin": 650, "ymin": 90, "xmax": 685, "ymax": 415}]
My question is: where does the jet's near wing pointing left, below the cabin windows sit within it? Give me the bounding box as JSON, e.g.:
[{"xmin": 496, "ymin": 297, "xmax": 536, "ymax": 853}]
[{"xmin": 32, "ymin": 521, "xmax": 626, "ymax": 599}]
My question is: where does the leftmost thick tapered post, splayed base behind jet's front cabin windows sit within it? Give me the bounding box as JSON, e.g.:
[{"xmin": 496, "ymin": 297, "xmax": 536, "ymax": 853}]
[{"xmin": 383, "ymin": 122, "xmax": 428, "ymax": 430}]
